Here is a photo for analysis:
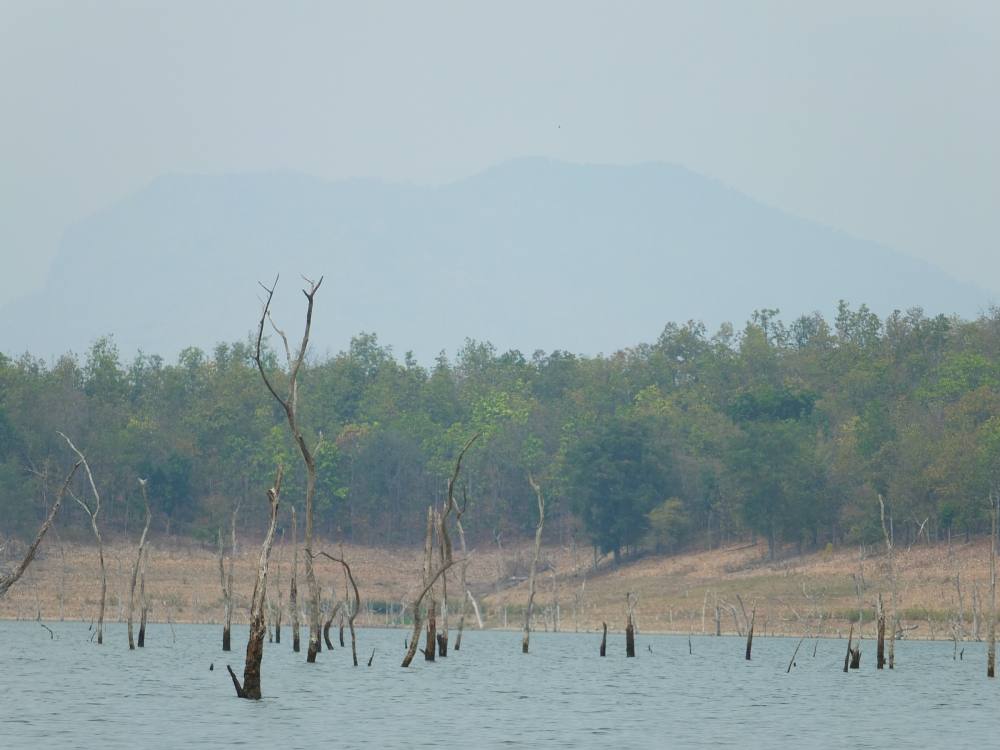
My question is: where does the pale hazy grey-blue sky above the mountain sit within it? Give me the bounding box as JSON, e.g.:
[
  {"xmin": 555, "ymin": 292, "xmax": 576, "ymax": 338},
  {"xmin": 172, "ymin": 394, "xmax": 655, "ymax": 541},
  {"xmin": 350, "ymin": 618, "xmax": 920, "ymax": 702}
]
[{"xmin": 0, "ymin": 0, "xmax": 1000, "ymax": 303}]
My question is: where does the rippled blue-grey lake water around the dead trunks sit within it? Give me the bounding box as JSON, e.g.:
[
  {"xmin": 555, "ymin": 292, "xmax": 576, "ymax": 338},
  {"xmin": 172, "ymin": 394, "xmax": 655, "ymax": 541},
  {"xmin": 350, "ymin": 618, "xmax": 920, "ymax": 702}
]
[{"xmin": 0, "ymin": 622, "xmax": 1000, "ymax": 750}]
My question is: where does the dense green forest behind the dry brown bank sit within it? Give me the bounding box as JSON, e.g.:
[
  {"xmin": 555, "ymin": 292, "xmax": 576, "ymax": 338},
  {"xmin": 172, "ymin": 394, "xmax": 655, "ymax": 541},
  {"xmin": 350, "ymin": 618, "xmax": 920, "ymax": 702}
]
[{"xmin": 0, "ymin": 304, "xmax": 1000, "ymax": 554}]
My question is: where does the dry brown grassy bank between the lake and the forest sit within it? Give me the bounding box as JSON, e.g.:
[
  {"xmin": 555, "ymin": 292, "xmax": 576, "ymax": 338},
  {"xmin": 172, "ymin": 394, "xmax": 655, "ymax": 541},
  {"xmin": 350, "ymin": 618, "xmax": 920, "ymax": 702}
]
[{"xmin": 0, "ymin": 539, "xmax": 989, "ymax": 639}]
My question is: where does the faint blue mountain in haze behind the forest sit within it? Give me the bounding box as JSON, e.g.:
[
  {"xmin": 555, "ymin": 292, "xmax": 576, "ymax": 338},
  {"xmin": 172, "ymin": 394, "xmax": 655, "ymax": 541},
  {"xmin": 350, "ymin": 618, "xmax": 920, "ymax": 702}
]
[{"xmin": 0, "ymin": 159, "xmax": 991, "ymax": 362}]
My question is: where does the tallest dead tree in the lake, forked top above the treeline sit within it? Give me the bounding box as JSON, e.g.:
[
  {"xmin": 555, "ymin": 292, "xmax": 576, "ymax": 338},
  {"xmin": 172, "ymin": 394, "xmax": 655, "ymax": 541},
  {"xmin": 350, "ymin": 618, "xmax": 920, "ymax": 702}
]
[{"xmin": 254, "ymin": 276, "xmax": 323, "ymax": 664}]
